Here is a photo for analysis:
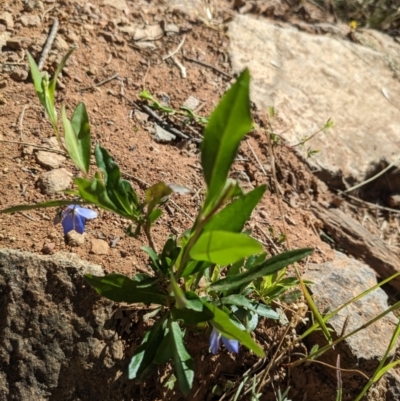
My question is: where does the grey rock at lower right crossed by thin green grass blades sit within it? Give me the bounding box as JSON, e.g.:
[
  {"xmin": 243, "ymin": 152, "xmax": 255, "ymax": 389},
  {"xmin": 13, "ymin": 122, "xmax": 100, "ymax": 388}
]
[{"xmin": 304, "ymin": 252, "xmax": 398, "ymax": 375}]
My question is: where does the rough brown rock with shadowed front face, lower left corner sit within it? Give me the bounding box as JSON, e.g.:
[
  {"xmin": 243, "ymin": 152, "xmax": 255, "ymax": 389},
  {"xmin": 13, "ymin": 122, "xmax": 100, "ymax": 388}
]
[{"xmin": 0, "ymin": 249, "xmax": 139, "ymax": 401}]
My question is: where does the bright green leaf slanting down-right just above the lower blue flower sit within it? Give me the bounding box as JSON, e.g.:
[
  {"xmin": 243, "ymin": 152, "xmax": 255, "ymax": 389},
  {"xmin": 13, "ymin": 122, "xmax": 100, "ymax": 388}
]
[{"xmin": 203, "ymin": 301, "xmax": 265, "ymax": 357}]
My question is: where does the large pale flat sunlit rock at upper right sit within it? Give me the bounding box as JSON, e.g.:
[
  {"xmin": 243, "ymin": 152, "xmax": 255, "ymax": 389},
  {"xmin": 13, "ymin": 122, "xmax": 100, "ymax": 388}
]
[{"xmin": 229, "ymin": 15, "xmax": 400, "ymax": 185}]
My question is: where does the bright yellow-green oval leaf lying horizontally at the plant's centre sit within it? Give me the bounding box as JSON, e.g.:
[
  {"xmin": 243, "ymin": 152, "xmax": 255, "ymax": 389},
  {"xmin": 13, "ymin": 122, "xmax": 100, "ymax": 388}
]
[{"xmin": 190, "ymin": 231, "xmax": 263, "ymax": 265}]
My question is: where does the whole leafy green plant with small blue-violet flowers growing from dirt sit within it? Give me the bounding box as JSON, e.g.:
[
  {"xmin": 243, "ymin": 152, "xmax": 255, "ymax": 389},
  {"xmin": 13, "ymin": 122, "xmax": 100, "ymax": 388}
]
[{"xmin": 1, "ymin": 49, "xmax": 312, "ymax": 395}]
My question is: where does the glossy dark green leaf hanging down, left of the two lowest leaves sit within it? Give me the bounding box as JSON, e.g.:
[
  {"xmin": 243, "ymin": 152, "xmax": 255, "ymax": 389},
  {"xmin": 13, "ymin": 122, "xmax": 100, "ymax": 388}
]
[{"xmin": 128, "ymin": 318, "xmax": 165, "ymax": 380}]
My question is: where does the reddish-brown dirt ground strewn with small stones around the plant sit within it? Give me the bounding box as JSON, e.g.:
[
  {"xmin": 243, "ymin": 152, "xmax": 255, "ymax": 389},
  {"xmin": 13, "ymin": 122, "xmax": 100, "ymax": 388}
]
[{"xmin": 0, "ymin": 0, "xmax": 394, "ymax": 400}]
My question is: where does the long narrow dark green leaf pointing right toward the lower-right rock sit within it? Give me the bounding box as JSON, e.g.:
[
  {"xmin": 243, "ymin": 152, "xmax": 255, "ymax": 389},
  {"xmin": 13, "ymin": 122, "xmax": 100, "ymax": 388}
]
[{"xmin": 211, "ymin": 248, "xmax": 313, "ymax": 291}]
